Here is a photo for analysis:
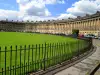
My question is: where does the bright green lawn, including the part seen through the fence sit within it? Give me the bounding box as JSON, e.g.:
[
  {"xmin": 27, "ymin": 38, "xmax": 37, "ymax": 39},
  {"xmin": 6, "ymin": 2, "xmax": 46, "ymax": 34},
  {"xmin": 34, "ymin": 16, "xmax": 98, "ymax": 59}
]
[{"xmin": 0, "ymin": 32, "xmax": 87, "ymax": 74}]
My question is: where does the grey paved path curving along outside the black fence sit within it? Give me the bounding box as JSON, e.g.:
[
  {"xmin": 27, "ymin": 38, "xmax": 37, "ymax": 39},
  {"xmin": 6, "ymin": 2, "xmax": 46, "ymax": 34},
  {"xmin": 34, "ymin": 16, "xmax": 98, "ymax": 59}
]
[{"xmin": 55, "ymin": 39, "xmax": 100, "ymax": 75}]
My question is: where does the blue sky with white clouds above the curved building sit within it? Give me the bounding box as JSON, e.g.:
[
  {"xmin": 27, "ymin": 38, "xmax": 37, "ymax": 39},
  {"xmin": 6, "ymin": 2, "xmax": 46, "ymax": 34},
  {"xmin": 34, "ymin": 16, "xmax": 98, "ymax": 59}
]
[{"xmin": 0, "ymin": 0, "xmax": 100, "ymax": 21}]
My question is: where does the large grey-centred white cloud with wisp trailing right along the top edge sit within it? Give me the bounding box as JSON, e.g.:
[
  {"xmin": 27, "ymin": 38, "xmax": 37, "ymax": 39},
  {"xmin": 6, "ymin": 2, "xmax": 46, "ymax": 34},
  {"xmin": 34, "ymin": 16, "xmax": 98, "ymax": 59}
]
[{"xmin": 17, "ymin": 0, "xmax": 65, "ymax": 16}]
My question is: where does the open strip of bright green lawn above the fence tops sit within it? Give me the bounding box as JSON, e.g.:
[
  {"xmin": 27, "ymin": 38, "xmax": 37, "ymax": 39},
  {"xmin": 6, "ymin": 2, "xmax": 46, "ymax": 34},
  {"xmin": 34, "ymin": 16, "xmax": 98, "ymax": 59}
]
[{"xmin": 0, "ymin": 32, "xmax": 79, "ymax": 46}]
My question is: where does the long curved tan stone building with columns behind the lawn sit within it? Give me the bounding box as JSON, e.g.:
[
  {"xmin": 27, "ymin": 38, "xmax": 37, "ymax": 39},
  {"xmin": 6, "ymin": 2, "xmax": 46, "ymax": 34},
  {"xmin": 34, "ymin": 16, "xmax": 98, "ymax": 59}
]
[{"xmin": 0, "ymin": 11, "xmax": 100, "ymax": 36}]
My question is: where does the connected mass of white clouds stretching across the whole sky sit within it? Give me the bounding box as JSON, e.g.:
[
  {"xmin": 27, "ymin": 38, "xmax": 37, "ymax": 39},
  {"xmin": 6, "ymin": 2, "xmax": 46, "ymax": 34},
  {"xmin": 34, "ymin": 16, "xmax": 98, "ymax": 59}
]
[{"xmin": 0, "ymin": 0, "xmax": 100, "ymax": 21}]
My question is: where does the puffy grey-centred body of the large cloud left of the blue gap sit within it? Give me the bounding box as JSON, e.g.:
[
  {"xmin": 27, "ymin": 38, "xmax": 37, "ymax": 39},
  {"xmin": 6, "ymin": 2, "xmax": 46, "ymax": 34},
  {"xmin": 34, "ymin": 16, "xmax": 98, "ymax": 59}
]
[{"xmin": 17, "ymin": 0, "xmax": 51, "ymax": 16}]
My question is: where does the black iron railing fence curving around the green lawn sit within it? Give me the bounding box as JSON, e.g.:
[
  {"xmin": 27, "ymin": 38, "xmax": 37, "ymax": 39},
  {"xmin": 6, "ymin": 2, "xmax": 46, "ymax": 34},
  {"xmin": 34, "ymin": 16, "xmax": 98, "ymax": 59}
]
[{"xmin": 0, "ymin": 38, "xmax": 92, "ymax": 75}]
